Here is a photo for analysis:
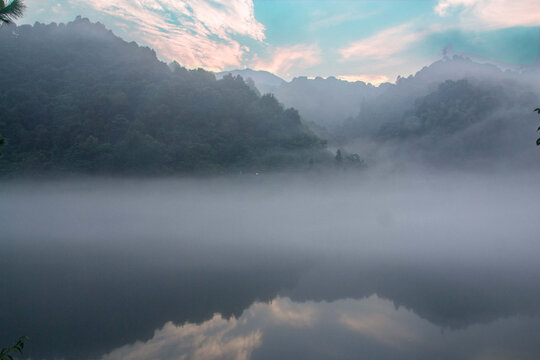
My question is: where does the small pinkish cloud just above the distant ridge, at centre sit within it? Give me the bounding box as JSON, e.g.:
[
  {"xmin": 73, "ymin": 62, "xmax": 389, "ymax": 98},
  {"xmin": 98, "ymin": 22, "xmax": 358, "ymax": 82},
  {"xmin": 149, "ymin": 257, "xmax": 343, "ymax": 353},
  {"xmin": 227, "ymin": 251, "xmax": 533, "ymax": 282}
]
[{"xmin": 253, "ymin": 44, "xmax": 321, "ymax": 77}]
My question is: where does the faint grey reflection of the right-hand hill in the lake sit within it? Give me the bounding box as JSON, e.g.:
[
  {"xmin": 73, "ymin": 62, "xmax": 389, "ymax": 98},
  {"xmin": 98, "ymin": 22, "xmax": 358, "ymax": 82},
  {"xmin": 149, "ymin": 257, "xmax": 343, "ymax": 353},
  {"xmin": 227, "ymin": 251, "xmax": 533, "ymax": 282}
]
[{"xmin": 281, "ymin": 259, "xmax": 540, "ymax": 329}]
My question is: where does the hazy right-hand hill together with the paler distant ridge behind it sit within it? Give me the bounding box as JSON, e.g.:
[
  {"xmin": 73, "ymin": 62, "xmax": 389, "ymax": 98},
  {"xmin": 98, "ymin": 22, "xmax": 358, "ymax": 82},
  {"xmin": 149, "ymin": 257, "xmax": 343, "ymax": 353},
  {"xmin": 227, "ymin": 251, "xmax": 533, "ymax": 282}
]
[{"xmin": 233, "ymin": 54, "xmax": 540, "ymax": 169}]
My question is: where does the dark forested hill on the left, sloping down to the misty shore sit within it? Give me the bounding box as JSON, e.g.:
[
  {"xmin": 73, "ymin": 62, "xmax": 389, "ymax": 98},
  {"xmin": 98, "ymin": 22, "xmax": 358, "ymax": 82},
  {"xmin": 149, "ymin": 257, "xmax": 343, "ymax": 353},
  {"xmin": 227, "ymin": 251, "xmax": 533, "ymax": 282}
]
[{"xmin": 0, "ymin": 18, "xmax": 323, "ymax": 174}]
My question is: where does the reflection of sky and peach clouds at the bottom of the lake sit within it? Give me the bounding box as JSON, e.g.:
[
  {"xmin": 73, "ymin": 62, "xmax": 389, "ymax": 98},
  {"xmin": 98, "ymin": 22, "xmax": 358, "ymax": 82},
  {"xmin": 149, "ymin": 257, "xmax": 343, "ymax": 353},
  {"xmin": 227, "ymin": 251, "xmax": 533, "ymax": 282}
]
[{"xmin": 102, "ymin": 295, "xmax": 540, "ymax": 360}]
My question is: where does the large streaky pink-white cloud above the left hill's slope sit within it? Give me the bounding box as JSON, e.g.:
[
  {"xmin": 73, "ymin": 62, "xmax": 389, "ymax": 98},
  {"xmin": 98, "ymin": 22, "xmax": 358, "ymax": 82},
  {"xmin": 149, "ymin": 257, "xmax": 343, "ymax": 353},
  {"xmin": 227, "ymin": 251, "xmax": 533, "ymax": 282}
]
[{"xmin": 72, "ymin": 0, "xmax": 265, "ymax": 70}]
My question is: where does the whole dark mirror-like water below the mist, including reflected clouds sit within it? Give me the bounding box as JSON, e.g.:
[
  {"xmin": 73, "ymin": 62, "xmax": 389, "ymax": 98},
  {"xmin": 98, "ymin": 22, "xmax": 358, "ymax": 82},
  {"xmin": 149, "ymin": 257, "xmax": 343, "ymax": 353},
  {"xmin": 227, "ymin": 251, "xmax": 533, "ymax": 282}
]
[{"xmin": 4, "ymin": 243, "xmax": 540, "ymax": 359}]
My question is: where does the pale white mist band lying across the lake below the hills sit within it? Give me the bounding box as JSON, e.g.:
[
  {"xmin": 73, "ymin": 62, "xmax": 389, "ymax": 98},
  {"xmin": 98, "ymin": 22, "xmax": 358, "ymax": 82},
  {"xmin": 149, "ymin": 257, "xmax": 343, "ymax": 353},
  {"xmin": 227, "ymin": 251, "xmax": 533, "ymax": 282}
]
[{"xmin": 0, "ymin": 172, "xmax": 539, "ymax": 258}]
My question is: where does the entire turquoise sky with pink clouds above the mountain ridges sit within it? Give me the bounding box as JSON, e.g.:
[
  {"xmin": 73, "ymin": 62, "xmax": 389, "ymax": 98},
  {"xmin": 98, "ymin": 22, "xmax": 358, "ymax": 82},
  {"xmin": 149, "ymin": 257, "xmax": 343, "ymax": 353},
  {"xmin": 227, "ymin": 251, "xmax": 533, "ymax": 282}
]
[{"xmin": 18, "ymin": 0, "xmax": 540, "ymax": 83}]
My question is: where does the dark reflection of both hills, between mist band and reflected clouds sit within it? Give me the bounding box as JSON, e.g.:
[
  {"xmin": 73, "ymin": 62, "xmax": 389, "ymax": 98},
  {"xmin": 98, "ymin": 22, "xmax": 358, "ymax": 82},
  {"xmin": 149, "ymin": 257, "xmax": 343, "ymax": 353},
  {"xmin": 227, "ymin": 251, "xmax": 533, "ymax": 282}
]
[{"xmin": 4, "ymin": 244, "xmax": 540, "ymax": 359}]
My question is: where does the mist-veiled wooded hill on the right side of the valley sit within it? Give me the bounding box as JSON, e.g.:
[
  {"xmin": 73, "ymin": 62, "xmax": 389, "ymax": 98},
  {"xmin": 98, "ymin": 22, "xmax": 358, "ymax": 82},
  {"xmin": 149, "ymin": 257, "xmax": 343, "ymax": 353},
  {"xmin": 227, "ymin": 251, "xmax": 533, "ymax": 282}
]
[{"xmin": 337, "ymin": 57, "xmax": 540, "ymax": 166}]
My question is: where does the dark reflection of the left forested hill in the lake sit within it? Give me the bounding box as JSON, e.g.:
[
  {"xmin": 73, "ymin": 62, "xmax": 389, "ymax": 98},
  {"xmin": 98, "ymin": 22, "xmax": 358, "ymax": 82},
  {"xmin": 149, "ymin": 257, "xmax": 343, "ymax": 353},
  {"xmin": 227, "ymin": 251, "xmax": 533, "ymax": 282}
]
[{"xmin": 0, "ymin": 243, "xmax": 305, "ymax": 360}]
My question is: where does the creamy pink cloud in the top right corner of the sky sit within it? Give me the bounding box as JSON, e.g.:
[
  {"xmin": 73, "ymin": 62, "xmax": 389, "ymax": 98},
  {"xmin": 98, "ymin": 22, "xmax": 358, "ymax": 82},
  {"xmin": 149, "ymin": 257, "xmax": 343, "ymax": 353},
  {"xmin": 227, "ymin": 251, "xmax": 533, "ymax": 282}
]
[{"xmin": 435, "ymin": 0, "xmax": 540, "ymax": 29}]
